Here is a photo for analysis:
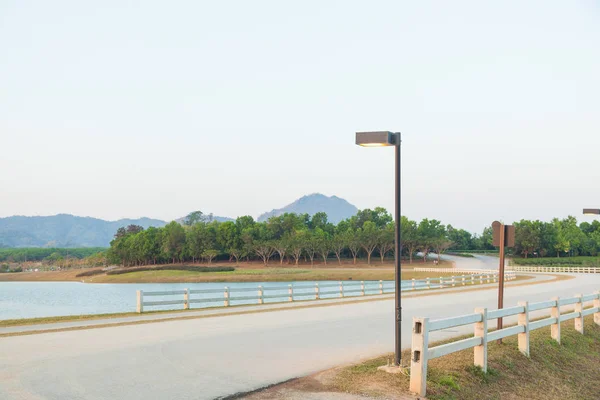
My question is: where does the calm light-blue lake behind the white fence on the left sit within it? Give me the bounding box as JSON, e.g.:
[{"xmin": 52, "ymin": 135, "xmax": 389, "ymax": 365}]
[{"xmin": 0, "ymin": 281, "xmax": 398, "ymax": 320}]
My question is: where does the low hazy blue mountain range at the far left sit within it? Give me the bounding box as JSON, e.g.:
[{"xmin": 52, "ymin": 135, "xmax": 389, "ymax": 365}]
[{"xmin": 0, "ymin": 214, "xmax": 166, "ymax": 247}]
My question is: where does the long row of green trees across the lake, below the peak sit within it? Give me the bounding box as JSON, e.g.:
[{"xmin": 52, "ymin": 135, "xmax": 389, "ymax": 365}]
[{"xmin": 108, "ymin": 207, "xmax": 493, "ymax": 266}]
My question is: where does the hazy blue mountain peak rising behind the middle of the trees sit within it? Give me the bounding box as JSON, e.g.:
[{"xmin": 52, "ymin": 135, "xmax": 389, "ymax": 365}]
[{"xmin": 258, "ymin": 193, "xmax": 358, "ymax": 224}]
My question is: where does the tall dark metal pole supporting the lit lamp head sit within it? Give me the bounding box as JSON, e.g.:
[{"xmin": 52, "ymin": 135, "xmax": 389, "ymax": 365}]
[{"xmin": 395, "ymin": 133, "xmax": 402, "ymax": 366}]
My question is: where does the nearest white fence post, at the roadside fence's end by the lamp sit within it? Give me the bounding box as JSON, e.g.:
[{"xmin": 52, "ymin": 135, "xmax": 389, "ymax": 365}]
[{"xmin": 410, "ymin": 318, "xmax": 429, "ymax": 396}]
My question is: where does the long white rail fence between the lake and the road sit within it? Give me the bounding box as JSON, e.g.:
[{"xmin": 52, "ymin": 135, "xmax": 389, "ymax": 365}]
[{"xmin": 136, "ymin": 272, "xmax": 516, "ymax": 313}]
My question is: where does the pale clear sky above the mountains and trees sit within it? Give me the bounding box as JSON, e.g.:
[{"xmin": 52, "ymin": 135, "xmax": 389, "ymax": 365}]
[{"xmin": 0, "ymin": 0, "xmax": 600, "ymax": 232}]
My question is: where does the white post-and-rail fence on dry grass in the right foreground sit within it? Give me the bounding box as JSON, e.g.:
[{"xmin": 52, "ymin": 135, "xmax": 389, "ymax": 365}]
[{"xmin": 410, "ymin": 291, "xmax": 600, "ymax": 396}]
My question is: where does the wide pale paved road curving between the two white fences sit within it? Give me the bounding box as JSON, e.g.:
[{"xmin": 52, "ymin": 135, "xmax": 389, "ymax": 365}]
[{"xmin": 0, "ymin": 274, "xmax": 600, "ymax": 400}]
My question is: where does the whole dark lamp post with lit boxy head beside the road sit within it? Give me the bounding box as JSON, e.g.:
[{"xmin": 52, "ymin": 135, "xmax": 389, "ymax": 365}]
[{"xmin": 356, "ymin": 131, "xmax": 402, "ymax": 367}]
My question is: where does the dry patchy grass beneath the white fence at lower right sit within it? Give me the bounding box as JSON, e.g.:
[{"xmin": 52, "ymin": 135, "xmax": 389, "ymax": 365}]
[{"xmin": 326, "ymin": 316, "xmax": 600, "ymax": 400}]
